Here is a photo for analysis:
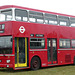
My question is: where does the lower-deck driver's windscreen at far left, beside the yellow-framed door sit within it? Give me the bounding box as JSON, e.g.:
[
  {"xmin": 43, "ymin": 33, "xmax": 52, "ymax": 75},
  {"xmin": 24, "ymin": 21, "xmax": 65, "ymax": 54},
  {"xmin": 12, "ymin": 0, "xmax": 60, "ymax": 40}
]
[{"xmin": 0, "ymin": 36, "xmax": 12, "ymax": 54}]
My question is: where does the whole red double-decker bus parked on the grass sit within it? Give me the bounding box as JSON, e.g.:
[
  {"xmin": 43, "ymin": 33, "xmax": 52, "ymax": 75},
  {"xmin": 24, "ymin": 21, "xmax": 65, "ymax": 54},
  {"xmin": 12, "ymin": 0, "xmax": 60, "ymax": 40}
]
[{"xmin": 0, "ymin": 5, "xmax": 75, "ymax": 70}]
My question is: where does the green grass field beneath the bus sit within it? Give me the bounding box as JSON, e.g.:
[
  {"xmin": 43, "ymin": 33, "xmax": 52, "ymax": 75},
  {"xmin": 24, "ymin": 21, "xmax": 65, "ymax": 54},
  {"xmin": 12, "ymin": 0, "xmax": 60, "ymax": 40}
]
[{"xmin": 0, "ymin": 65, "xmax": 75, "ymax": 75}]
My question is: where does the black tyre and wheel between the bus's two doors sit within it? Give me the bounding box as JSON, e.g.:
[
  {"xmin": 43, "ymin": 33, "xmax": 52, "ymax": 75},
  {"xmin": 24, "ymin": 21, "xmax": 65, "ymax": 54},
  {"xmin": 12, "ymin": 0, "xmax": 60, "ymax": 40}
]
[{"xmin": 31, "ymin": 57, "xmax": 40, "ymax": 70}]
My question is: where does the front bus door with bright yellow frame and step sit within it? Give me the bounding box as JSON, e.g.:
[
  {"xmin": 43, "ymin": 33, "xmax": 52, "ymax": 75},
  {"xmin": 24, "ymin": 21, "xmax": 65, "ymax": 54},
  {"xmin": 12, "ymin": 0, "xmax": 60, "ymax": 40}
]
[{"xmin": 15, "ymin": 37, "xmax": 27, "ymax": 67}]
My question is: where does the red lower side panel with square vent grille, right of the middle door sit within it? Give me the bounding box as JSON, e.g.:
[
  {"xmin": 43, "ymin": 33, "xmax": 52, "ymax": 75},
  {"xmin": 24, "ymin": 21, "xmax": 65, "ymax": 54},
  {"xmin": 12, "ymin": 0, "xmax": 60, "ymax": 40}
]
[{"xmin": 58, "ymin": 50, "xmax": 73, "ymax": 65}]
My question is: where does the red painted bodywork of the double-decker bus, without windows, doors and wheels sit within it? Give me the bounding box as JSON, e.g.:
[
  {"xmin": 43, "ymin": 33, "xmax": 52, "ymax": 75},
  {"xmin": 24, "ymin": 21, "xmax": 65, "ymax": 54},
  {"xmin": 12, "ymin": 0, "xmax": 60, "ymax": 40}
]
[{"xmin": 0, "ymin": 5, "xmax": 75, "ymax": 70}]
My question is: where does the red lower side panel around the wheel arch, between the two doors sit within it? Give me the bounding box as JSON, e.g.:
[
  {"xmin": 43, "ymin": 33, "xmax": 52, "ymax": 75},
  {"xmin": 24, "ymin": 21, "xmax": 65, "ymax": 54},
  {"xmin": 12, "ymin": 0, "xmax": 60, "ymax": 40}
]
[{"xmin": 29, "ymin": 49, "xmax": 48, "ymax": 67}]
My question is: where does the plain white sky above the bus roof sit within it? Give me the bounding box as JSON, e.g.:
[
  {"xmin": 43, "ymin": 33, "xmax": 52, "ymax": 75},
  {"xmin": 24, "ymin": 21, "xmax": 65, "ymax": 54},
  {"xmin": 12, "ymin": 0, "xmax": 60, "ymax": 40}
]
[{"xmin": 0, "ymin": 0, "xmax": 75, "ymax": 16}]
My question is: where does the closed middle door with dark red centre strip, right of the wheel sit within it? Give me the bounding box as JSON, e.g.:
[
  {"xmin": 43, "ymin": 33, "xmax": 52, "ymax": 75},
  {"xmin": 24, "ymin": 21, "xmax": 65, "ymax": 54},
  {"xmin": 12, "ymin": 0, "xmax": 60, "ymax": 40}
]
[{"xmin": 47, "ymin": 38, "xmax": 57, "ymax": 65}]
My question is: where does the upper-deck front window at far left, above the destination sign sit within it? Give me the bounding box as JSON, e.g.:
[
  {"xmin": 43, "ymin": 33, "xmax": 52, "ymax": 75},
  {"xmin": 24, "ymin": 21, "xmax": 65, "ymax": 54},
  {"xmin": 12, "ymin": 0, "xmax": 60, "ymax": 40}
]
[{"xmin": 0, "ymin": 9, "xmax": 12, "ymax": 21}]
